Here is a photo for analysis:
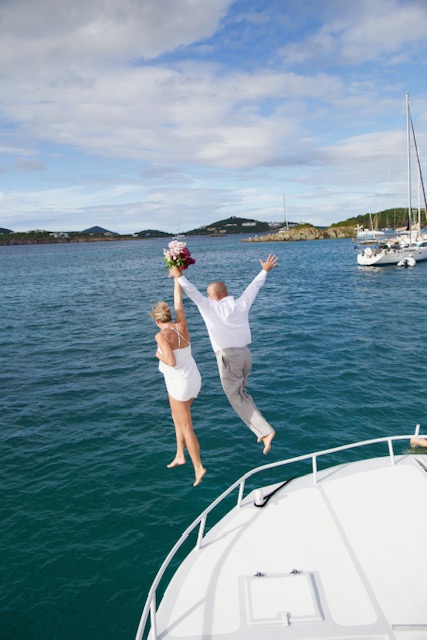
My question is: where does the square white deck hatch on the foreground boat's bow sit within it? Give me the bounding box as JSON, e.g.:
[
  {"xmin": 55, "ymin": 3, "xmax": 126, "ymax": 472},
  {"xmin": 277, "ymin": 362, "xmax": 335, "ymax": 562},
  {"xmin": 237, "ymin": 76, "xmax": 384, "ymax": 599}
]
[{"xmin": 243, "ymin": 572, "xmax": 323, "ymax": 626}]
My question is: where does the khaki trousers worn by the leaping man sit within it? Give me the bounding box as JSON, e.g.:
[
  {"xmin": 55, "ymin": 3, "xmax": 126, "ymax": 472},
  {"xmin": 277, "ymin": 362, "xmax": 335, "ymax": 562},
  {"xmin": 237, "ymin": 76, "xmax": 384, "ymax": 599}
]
[{"xmin": 215, "ymin": 347, "xmax": 274, "ymax": 438}]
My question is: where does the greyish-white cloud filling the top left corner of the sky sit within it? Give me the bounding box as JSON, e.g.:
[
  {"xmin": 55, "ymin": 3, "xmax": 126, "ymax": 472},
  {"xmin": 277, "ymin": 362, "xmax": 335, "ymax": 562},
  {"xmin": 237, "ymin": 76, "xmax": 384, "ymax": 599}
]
[{"xmin": 0, "ymin": 0, "xmax": 233, "ymax": 66}]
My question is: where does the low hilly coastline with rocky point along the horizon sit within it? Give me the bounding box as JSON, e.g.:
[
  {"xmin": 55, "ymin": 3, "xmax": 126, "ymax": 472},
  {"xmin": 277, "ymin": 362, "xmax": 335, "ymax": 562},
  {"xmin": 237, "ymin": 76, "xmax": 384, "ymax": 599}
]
[{"xmin": 0, "ymin": 208, "xmax": 422, "ymax": 245}]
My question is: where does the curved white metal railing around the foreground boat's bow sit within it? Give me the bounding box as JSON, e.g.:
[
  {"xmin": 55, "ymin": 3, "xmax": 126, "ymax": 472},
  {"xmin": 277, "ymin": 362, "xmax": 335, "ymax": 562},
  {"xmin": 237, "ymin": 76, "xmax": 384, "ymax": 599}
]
[{"xmin": 136, "ymin": 424, "xmax": 420, "ymax": 640}]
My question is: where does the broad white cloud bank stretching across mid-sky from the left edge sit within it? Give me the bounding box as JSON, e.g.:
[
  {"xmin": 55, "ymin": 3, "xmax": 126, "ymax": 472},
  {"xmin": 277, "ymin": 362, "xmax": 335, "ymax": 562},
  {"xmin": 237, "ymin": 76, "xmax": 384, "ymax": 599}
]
[{"xmin": 0, "ymin": 64, "xmax": 348, "ymax": 168}]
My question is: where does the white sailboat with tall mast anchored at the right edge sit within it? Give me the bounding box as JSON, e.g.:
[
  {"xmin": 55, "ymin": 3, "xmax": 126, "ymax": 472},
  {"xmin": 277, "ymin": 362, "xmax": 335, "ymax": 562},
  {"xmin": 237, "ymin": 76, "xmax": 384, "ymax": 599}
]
[{"xmin": 356, "ymin": 93, "xmax": 427, "ymax": 267}]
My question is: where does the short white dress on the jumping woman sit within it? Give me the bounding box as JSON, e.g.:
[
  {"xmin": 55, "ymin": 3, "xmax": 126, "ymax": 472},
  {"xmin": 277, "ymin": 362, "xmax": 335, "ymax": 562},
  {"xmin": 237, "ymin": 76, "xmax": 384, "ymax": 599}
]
[{"xmin": 159, "ymin": 327, "xmax": 202, "ymax": 402}]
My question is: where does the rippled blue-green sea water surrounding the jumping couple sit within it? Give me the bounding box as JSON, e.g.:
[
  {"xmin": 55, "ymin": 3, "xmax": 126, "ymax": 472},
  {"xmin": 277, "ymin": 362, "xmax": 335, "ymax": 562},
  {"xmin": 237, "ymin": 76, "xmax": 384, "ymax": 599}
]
[{"xmin": 0, "ymin": 237, "xmax": 427, "ymax": 640}]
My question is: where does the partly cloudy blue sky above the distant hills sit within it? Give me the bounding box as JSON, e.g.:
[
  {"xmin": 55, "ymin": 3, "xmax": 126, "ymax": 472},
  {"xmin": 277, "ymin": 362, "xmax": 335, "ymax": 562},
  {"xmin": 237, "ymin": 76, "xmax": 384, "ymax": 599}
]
[{"xmin": 0, "ymin": 0, "xmax": 427, "ymax": 234}]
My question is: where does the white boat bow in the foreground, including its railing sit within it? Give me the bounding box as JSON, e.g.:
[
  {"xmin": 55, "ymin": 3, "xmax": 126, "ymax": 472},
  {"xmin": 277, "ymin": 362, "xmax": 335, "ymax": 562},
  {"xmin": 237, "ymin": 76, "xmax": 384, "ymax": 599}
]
[{"xmin": 136, "ymin": 425, "xmax": 427, "ymax": 640}]
